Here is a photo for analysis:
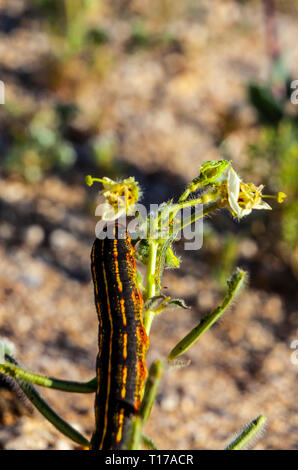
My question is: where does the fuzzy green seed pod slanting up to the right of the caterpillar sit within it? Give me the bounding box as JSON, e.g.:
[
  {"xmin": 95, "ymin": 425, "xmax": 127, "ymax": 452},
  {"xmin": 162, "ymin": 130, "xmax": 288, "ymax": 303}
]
[{"xmin": 168, "ymin": 269, "xmax": 246, "ymax": 360}]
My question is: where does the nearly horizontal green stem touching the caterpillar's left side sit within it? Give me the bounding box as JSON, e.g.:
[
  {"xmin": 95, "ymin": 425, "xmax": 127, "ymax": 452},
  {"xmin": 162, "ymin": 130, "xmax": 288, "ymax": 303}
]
[{"xmin": 0, "ymin": 363, "xmax": 97, "ymax": 393}]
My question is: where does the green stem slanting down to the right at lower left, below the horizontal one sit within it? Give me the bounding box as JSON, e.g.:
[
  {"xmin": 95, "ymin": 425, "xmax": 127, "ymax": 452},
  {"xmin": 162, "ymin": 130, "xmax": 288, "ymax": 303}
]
[{"xmin": 5, "ymin": 355, "xmax": 89, "ymax": 447}]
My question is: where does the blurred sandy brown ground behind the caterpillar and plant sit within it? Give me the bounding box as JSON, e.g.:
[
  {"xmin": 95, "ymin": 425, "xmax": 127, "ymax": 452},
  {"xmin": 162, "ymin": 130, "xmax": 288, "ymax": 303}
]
[{"xmin": 0, "ymin": 0, "xmax": 298, "ymax": 449}]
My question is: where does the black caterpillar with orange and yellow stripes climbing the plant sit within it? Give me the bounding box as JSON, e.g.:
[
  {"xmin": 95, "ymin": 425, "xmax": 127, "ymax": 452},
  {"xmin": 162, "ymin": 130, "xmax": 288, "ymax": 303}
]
[{"xmin": 90, "ymin": 225, "xmax": 148, "ymax": 450}]
